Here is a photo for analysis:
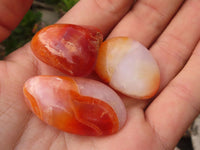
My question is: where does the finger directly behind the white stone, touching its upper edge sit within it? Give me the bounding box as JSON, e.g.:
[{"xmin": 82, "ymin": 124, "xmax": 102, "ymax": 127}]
[{"xmin": 110, "ymin": 0, "xmax": 184, "ymax": 47}]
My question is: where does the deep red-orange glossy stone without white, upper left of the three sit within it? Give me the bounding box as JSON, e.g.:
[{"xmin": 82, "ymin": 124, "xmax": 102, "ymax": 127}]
[{"xmin": 31, "ymin": 24, "xmax": 103, "ymax": 76}]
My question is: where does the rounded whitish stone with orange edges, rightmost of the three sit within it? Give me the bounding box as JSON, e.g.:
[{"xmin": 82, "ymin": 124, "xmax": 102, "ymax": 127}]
[{"xmin": 96, "ymin": 37, "xmax": 160, "ymax": 99}]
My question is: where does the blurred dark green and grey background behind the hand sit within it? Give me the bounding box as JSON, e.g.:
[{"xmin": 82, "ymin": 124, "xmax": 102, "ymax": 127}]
[{"xmin": 0, "ymin": 0, "xmax": 200, "ymax": 150}]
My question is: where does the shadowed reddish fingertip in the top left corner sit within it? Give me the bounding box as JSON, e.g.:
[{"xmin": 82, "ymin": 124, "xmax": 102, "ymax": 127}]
[{"xmin": 0, "ymin": 0, "xmax": 32, "ymax": 42}]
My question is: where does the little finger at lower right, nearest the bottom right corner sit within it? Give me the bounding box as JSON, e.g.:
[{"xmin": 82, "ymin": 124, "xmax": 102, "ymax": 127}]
[{"xmin": 146, "ymin": 41, "xmax": 200, "ymax": 149}]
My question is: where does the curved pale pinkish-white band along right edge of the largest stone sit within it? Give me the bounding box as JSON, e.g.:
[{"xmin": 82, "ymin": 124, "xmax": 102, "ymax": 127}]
[{"xmin": 75, "ymin": 78, "xmax": 127, "ymax": 129}]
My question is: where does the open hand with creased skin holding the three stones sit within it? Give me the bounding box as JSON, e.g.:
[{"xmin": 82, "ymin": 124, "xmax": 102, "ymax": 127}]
[{"xmin": 0, "ymin": 0, "xmax": 200, "ymax": 150}]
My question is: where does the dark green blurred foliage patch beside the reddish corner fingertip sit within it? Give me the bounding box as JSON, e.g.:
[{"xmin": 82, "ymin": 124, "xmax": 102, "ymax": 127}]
[{"xmin": 2, "ymin": 10, "xmax": 42, "ymax": 55}]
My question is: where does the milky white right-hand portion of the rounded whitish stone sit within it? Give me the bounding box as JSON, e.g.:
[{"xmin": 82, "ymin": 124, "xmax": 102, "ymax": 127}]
[{"xmin": 110, "ymin": 41, "xmax": 159, "ymax": 98}]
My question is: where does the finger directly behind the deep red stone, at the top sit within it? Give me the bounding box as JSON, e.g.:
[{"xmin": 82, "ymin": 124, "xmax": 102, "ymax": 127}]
[{"xmin": 59, "ymin": 0, "xmax": 134, "ymax": 36}]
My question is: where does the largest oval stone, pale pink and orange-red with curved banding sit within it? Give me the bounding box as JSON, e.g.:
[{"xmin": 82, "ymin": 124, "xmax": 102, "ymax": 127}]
[{"xmin": 24, "ymin": 76, "xmax": 127, "ymax": 136}]
